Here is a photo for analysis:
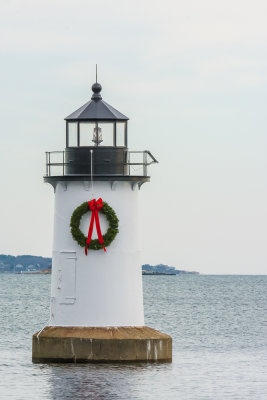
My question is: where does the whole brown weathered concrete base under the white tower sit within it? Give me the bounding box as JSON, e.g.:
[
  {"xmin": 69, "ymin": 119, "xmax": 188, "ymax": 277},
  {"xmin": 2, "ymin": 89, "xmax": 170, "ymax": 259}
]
[{"xmin": 32, "ymin": 326, "xmax": 172, "ymax": 363}]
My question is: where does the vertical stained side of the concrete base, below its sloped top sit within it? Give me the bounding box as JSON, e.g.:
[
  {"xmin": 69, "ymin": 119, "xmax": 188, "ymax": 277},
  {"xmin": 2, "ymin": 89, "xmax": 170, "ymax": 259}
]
[{"xmin": 32, "ymin": 337, "xmax": 172, "ymax": 363}]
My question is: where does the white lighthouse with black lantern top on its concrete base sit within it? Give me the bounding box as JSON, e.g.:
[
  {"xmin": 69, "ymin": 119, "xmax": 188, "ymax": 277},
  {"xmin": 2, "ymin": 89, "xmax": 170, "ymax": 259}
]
[{"xmin": 32, "ymin": 77, "xmax": 172, "ymax": 362}]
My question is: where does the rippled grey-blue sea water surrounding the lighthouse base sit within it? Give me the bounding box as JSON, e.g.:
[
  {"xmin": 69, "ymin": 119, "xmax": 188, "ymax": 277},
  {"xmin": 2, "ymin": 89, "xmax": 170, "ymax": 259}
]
[{"xmin": 0, "ymin": 274, "xmax": 267, "ymax": 400}]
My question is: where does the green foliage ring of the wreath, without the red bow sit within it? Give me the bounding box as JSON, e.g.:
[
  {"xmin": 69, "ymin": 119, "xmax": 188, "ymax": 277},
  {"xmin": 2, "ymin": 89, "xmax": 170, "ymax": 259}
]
[{"xmin": 70, "ymin": 201, "xmax": 119, "ymax": 250}]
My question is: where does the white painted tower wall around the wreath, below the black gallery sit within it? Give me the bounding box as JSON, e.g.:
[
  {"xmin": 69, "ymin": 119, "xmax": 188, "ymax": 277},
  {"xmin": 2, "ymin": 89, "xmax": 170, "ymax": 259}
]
[{"xmin": 50, "ymin": 181, "xmax": 144, "ymax": 326}]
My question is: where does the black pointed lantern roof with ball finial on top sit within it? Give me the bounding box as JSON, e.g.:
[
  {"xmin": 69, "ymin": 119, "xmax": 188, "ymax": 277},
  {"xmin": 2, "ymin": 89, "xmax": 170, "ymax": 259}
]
[{"xmin": 65, "ymin": 82, "xmax": 129, "ymax": 121}]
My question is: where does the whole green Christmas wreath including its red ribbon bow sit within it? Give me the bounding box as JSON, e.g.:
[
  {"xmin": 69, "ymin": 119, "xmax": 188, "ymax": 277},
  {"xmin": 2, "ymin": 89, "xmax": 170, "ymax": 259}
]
[{"xmin": 70, "ymin": 198, "xmax": 119, "ymax": 255}]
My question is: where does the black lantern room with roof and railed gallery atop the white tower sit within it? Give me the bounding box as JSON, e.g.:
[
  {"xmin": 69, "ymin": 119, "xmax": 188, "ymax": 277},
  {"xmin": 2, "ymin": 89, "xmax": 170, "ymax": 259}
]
[{"xmin": 45, "ymin": 82, "xmax": 157, "ymax": 185}]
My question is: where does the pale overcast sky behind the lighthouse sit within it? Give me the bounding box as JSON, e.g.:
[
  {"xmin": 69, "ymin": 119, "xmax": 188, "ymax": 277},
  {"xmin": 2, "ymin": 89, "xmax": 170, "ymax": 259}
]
[{"xmin": 0, "ymin": 0, "xmax": 267, "ymax": 274}]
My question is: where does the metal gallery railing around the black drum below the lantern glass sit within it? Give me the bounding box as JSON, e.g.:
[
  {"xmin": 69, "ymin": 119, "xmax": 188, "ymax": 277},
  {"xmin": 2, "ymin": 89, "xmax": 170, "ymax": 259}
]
[{"xmin": 46, "ymin": 150, "xmax": 158, "ymax": 177}]
